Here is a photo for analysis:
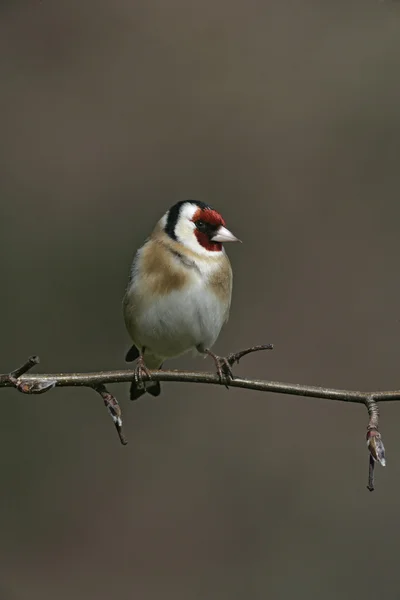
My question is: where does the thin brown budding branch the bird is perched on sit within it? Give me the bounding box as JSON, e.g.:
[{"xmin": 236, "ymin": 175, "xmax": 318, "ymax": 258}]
[{"xmin": 0, "ymin": 344, "xmax": 390, "ymax": 491}]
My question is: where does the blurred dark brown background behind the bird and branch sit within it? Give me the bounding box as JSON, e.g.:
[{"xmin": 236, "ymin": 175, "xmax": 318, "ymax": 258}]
[{"xmin": 0, "ymin": 0, "xmax": 400, "ymax": 600}]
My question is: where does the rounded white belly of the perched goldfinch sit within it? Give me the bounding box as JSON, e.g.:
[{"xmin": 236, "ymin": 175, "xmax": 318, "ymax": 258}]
[{"xmin": 136, "ymin": 281, "xmax": 227, "ymax": 358}]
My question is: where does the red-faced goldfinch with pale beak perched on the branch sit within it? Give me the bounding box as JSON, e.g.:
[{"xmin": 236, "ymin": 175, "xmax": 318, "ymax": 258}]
[{"xmin": 123, "ymin": 200, "xmax": 241, "ymax": 400}]
